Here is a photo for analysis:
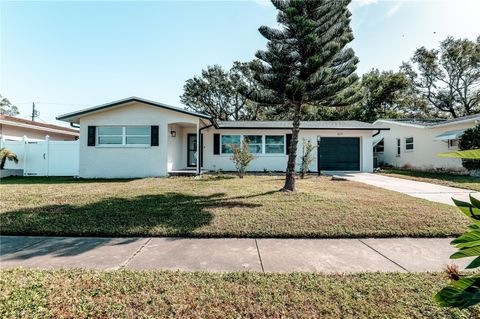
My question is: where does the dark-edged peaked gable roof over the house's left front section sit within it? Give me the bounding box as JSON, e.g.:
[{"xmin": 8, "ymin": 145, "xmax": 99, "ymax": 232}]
[{"xmin": 57, "ymin": 96, "xmax": 212, "ymax": 122}]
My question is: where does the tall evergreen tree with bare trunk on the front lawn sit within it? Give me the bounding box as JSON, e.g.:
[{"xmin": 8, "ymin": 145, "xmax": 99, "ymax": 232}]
[{"xmin": 256, "ymin": 0, "xmax": 358, "ymax": 191}]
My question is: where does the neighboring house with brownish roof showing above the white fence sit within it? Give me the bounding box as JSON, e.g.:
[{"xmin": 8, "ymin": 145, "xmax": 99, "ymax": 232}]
[{"xmin": 0, "ymin": 115, "xmax": 79, "ymax": 142}]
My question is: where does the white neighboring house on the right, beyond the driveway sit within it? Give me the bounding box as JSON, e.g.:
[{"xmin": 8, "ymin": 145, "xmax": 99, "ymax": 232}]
[{"xmin": 373, "ymin": 114, "xmax": 480, "ymax": 170}]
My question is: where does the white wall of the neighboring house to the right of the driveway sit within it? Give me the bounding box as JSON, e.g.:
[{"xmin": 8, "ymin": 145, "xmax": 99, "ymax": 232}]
[{"xmin": 376, "ymin": 121, "xmax": 475, "ymax": 169}]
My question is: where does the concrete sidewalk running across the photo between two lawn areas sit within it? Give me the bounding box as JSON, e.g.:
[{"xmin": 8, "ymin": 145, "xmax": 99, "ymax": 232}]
[{"xmin": 0, "ymin": 236, "xmax": 471, "ymax": 273}]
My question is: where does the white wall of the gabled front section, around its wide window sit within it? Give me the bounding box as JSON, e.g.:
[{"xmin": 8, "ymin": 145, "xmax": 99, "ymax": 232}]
[{"xmin": 79, "ymin": 102, "xmax": 199, "ymax": 178}]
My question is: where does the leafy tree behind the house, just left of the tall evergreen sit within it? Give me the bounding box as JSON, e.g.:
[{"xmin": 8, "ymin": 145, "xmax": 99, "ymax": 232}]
[{"xmin": 180, "ymin": 61, "xmax": 261, "ymax": 121}]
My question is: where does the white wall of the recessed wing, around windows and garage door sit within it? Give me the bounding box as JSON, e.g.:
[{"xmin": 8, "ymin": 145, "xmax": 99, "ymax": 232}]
[{"xmin": 203, "ymin": 128, "xmax": 374, "ymax": 172}]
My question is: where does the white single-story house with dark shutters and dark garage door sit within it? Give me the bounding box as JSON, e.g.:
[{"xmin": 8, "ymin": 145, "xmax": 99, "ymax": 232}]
[{"xmin": 57, "ymin": 97, "xmax": 388, "ymax": 178}]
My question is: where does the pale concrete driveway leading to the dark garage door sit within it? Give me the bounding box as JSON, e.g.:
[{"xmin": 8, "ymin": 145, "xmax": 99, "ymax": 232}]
[{"xmin": 335, "ymin": 172, "xmax": 480, "ymax": 205}]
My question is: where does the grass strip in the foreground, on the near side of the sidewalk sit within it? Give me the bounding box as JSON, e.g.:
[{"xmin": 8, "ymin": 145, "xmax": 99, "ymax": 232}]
[{"xmin": 0, "ymin": 269, "xmax": 480, "ymax": 319}]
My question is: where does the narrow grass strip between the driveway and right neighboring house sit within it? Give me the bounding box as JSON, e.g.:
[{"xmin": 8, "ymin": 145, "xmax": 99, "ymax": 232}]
[{"xmin": 381, "ymin": 169, "xmax": 480, "ymax": 192}]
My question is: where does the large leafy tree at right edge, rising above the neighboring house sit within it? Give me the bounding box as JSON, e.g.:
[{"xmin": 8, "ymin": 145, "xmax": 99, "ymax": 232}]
[{"xmin": 402, "ymin": 36, "xmax": 480, "ymax": 118}]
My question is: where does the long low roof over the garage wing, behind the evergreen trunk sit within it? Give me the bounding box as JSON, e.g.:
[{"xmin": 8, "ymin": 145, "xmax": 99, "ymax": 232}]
[{"xmin": 217, "ymin": 121, "xmax": 389, "ymax": 130}]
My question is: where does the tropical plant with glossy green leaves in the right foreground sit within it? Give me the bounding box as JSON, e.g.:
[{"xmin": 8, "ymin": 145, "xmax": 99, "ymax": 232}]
[{"xmin": 435, "ymin": 195, "xmax": 480, "ymax": 308}]
